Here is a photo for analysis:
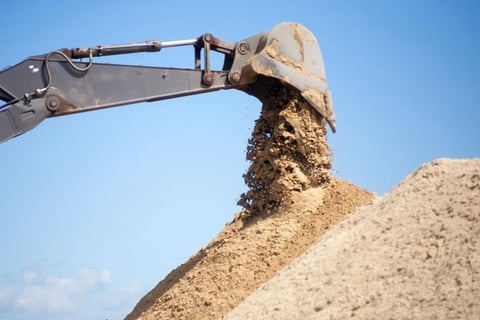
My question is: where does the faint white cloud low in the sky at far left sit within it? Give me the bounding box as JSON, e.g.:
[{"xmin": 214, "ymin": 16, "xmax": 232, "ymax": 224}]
[{"xmin": 0, "ymin": 269, "xmax": 112, "ymax": 315}]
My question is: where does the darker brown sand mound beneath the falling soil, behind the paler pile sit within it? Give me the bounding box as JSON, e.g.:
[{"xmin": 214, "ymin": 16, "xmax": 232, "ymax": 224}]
[{"xmin": 126, "ymin": 180, "xmax": 372, "ymax": 320}]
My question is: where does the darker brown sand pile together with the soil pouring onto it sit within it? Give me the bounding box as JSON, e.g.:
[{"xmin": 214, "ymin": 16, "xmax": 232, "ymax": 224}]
[{"xmin": 126, "ymin": 82, "xmax": 373, "ymax": 320}]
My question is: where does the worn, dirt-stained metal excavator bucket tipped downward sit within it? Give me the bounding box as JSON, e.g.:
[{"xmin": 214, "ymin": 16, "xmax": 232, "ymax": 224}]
[{"xmin": 240, "ymin": 22, "xmax": 336, "ymax": 132}]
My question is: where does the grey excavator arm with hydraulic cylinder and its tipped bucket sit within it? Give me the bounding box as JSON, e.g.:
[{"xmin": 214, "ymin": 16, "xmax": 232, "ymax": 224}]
[{"xmin": 0, "ymin": 22, "xmax": 336, "ymax": 142}]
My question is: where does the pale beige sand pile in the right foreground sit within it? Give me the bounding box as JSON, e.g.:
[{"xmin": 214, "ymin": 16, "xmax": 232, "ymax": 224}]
[{"xmin": 223, "ymin": 158, "xmax": 480, "ymax": 320}]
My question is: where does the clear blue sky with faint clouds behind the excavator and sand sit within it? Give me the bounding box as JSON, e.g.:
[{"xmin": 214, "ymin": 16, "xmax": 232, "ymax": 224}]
[{"xmin": 0, "ymin": 0, "xmax": 480, "ymax": 320}]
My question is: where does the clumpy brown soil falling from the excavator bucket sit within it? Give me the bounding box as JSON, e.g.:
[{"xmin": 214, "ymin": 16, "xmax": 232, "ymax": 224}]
[{"xmin": 239, "ymin": 83, "xmax": 331, "ymax": 214}]
